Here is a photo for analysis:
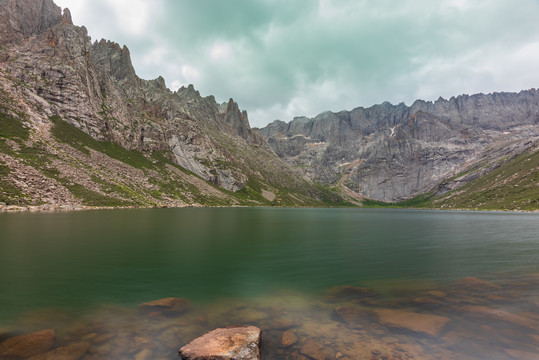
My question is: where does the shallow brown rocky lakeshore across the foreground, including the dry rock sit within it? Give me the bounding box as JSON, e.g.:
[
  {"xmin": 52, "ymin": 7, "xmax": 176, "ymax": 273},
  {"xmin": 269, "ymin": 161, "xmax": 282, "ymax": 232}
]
[{"xmin": 0, "ymin": 274, "xmax": 539, "ymax": 360}]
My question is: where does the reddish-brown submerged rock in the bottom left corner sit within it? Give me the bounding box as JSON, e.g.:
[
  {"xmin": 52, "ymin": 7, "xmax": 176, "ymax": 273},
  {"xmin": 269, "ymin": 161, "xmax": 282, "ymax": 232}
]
[{"xmin": 0, "ymin": 329, "xmax": 56, "ymax": 359}]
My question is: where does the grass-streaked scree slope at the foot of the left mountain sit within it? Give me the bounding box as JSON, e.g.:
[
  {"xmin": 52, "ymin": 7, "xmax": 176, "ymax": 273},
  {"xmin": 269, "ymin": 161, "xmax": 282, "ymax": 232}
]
[{"xmin": 0, "ymin": 106, "xmax": 349, "ymax": 207}]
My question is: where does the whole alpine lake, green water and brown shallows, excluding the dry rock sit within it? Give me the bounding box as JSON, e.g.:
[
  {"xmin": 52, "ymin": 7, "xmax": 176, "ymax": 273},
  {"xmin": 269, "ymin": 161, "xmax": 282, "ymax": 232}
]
[{"xmin": 0, "ymin": 208, "xmax": 539, "ymax": 360}]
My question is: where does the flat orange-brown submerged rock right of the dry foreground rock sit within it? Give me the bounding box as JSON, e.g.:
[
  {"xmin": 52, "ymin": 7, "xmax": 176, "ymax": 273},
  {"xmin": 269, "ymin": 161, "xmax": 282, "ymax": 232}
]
[{"xmin": 373, "ymin": 309, "xmax": 450, "ymax": 336}]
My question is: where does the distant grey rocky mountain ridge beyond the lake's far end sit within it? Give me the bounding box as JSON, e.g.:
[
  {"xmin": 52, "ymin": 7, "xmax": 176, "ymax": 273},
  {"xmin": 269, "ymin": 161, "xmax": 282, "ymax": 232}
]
[{"xmin": 260, "ymin": 89, "xmax": 539, "ymax": 207}]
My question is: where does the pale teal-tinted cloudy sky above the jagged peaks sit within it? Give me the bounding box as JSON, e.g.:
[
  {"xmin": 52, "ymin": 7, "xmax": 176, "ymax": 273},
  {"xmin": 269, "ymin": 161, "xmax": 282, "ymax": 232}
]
[{"xmin": 52, "ymin": 0, "xmax": 539, "ymax": 127}]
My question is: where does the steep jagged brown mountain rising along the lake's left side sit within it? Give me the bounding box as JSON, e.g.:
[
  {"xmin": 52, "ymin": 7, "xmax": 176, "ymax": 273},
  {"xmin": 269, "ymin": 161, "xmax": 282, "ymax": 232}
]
[{"xmin": 0, "ymin": 0, "xmax": 343, "ymax": 208}]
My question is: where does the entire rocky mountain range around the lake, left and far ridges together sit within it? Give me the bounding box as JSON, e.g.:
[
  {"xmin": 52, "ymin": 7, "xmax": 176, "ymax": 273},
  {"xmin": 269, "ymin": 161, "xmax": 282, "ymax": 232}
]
[{"xmin": 0, "ymin": 0, "xmax": 539, "ymax": 209}]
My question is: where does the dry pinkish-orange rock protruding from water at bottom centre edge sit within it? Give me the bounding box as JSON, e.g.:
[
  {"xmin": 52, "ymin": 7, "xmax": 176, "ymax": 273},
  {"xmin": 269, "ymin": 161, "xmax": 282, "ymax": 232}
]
[{"xmin": 180, "ymin": 326, "xmax": 261, "ymax": 360}]
